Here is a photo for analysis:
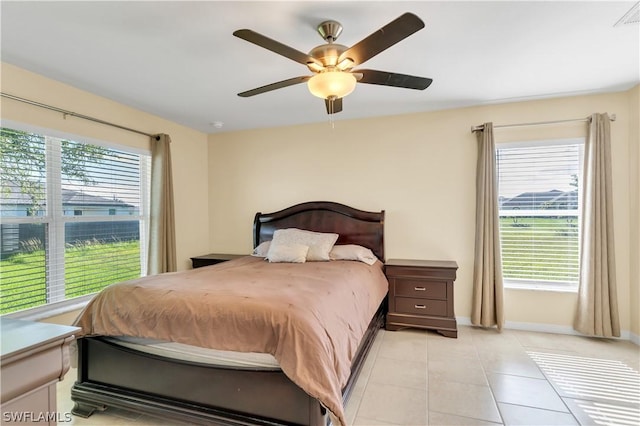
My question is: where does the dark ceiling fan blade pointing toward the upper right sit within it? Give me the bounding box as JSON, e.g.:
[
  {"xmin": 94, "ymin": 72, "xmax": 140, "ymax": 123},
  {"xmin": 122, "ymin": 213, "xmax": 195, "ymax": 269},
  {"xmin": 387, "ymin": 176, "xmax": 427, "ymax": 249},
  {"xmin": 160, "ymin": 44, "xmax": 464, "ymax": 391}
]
[{"xmin": 338, "ymin": 12, "xmax": 424, "ymax": 65}]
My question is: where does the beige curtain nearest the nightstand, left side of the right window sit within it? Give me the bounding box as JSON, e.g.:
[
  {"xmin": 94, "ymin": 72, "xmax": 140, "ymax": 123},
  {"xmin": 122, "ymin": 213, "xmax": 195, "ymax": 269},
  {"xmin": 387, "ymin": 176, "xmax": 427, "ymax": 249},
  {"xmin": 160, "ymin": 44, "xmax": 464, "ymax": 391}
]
[{"xmin": 471, "ymin": 123, "xmax": 504, "ymax": 330}]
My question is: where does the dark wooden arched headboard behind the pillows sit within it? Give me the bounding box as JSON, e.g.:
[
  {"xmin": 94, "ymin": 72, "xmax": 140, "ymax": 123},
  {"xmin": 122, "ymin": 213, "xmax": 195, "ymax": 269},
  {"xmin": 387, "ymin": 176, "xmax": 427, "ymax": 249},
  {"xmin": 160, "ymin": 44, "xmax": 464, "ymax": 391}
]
[{"xmin": 253, "ymin": 201, "xmax": 385, "ymax": 262}]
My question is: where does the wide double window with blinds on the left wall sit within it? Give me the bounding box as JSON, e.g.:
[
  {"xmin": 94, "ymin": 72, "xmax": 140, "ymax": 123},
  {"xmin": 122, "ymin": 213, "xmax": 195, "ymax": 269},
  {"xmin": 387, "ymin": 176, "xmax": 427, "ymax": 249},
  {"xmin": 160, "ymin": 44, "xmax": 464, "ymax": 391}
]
[{"xmin": 0, "ymin": 128, "xmax": 150, "ymax": 314}]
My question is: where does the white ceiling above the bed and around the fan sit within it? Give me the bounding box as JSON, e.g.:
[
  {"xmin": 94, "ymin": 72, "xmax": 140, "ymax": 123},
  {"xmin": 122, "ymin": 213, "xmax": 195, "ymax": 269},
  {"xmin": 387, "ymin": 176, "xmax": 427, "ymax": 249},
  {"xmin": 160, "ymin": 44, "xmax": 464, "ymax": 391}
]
[{"xmin": 0, "ymin": 1, "xmax": 640, "ymax": 133}]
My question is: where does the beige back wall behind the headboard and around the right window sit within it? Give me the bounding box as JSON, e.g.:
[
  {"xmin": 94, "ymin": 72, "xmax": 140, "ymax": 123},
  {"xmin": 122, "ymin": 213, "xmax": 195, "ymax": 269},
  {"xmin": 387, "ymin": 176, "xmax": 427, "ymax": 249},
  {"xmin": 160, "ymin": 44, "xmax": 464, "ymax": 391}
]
[{"xmin": 209, "ymin": 88, "xmax": 638, "ymax": 334}]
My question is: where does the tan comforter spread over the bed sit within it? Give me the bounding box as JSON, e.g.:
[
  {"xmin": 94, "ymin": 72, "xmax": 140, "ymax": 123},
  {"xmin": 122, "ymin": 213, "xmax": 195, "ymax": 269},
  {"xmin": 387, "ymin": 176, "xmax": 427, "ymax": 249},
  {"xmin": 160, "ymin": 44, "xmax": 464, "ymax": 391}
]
[{"xmin": 75, "ymin": 256, "xmax": 388, "ymax": 425}]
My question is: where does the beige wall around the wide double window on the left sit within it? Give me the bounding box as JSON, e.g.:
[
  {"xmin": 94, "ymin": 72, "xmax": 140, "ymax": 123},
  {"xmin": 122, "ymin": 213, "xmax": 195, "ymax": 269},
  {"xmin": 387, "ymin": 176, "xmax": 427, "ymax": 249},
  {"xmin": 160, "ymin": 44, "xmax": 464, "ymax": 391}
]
[{"xmin": 0, "ymin": 63, "xmax": 209, "ymax": 269}]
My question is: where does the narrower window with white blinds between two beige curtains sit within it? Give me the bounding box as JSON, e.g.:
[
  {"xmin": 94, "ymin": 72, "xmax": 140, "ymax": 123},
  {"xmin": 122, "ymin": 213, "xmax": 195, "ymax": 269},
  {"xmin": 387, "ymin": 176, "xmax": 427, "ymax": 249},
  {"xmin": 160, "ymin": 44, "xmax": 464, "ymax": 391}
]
[{"xmin": 496, "ymin": 139, "xmax": 583, "ymax": 288}]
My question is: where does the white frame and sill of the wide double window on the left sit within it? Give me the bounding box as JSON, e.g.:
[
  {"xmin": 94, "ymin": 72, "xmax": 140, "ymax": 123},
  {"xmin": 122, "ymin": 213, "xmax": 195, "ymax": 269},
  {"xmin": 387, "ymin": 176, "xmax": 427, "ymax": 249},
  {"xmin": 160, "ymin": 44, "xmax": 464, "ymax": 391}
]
[{"xmin": 1, "ymin": 119, "xmax": 151, "ymax": 320}]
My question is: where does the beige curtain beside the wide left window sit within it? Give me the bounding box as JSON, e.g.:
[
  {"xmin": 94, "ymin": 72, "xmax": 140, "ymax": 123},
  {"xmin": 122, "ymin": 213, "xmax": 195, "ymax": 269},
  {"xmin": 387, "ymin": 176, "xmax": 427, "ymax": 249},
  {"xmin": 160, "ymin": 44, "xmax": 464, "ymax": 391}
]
[{"xmin": 147, "ymin": 135, "xmax": 177, "ymax": 275}]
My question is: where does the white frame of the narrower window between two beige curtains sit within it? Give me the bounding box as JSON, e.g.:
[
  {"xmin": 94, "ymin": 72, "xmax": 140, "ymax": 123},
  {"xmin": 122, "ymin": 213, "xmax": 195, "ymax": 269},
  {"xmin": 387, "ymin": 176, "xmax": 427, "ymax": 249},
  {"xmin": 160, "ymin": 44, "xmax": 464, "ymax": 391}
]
[{"xmin": 495, "ymin": 136, "xmax": 585, "ymax": 293}]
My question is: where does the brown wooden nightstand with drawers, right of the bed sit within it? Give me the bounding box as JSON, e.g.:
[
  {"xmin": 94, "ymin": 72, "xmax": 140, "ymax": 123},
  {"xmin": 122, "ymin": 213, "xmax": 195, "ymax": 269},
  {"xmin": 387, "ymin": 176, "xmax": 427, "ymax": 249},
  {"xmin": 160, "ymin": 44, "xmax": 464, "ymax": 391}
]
[{"xmin": 385, "ymin": 259, "xmax": 458, "ymax": 337}]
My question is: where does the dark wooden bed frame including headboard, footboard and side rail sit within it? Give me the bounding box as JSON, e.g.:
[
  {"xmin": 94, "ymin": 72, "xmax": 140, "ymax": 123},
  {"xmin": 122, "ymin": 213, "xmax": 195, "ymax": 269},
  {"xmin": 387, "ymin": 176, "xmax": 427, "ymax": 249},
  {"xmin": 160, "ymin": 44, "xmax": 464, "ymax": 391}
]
[{"xmin": 71, "ymin": 201, "xmax": 386, "ymax": 426}]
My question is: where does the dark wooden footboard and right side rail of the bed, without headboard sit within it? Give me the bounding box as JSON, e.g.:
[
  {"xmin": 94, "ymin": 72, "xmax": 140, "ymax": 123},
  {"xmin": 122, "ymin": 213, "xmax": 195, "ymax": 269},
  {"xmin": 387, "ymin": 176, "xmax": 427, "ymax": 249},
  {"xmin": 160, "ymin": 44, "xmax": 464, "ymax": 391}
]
[{"xmin": 71, "ymin": 300, "xmax": 386, "ymax": 426}]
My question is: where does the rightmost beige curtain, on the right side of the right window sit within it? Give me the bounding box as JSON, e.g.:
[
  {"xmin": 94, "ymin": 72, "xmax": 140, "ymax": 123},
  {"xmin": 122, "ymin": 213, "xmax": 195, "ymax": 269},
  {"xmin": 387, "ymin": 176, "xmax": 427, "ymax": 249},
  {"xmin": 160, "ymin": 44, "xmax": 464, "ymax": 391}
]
[{"xmin": 573, "ymin": 113, "xmax": 620, "ymax": 337}]
